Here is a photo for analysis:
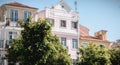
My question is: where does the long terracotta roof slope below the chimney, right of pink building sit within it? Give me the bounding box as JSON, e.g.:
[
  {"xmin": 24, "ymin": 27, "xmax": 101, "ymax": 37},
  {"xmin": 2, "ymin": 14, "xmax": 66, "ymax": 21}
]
[{"xmin": 80, "ymin": 36, "xmax": 110, "ymax": 43}]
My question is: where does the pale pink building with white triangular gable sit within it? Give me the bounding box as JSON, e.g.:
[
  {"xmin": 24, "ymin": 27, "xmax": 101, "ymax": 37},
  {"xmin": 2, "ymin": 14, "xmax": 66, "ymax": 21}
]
[{"xmin": 38, "ymin": 0, "xmax": 79, "ymax": 61}]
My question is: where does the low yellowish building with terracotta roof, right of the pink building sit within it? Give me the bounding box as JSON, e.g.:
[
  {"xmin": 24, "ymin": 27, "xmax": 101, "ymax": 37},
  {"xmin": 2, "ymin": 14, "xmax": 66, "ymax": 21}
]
[{"xmin": 80, "ymin": 25, "xmax": 111, "ymax": 47}]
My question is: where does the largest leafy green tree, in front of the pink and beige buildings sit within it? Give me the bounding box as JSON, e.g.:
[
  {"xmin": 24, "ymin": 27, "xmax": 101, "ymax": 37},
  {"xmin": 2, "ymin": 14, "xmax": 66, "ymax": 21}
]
[{"xmin": 7, "ymin": 19, "xmax": 71, "ymax": 65}]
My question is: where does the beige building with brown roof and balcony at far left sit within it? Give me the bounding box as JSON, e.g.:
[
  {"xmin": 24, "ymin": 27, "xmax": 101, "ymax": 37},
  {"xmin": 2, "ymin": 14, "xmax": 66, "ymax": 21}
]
[{"xmin": 0, "ymin": 2, "xmax": 37, "ymax": 65}]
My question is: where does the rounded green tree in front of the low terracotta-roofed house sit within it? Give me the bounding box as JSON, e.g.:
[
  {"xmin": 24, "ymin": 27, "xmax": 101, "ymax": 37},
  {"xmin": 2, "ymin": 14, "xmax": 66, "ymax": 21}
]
[{"xmin": 78, "ymin": 43, "xmax": 111, "ymax": 65}]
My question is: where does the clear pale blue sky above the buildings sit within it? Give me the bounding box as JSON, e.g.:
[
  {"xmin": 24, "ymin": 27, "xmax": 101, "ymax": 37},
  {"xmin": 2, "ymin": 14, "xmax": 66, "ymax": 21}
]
[{"xmin": 0, "ymin": 0, "xmax": 120, "ymax": 41}]
